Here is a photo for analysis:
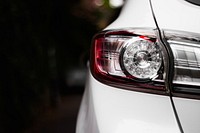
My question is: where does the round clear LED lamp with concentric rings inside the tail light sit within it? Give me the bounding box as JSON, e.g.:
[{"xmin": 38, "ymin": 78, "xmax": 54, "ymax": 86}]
[{"xmin": 122, "ymin": 39, "xmax": 162, "ymax": 79}]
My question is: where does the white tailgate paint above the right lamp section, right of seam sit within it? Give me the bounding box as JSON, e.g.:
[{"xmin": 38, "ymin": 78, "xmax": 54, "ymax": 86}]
[{"xmin": 151, "ymin": 0, "xmax": 200, "ymax": 33}]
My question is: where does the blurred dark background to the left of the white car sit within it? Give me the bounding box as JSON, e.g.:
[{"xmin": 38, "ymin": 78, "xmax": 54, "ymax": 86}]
[{"xmin": 0, "ymin": 0, "xmax": 123, "ymax": 133}]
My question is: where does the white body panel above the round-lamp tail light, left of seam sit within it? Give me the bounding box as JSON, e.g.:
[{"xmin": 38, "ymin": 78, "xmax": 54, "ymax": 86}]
[{"xmin": 106, "ymin": 0, "xmax": 156, "ymax": 29}]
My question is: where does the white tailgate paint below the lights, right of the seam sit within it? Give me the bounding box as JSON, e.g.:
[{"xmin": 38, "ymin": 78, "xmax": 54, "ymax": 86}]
[{"xmin": 173, "ymin": 98, "xmax": 200, "ymax": 133}]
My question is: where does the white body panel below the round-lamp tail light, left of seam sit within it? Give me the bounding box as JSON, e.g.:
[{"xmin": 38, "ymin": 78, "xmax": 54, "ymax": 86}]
[{"xmin": 77, "ymin": 73, "xmax": 180, "ymax": 133}]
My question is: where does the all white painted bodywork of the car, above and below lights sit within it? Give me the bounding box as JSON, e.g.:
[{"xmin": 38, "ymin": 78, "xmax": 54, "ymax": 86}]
[{"xmin": 76, "ymin": 0, "xmax": 200, "ymax": 133}]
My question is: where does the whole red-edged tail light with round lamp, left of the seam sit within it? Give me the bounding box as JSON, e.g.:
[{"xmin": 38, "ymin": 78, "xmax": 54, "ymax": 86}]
[{"xmin": 90, "ymin": 29, "xmax": 167, "ymax": 94}]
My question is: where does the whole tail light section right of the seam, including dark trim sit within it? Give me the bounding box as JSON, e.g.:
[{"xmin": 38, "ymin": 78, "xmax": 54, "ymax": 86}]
[{"xmin": 165, "ymin": 31, "xmax": 200, "ymax": 93}]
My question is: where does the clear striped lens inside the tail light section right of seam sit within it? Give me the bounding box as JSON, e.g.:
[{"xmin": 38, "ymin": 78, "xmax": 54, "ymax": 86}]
[{"xmin": 170, "ymin": 42, "xmax": 200, "ymax": 85}]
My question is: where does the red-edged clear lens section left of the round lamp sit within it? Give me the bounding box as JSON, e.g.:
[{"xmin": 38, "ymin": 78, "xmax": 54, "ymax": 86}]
[{"xmin": 95, "ymin": 37, "xmax": 126, "ymax": 76}]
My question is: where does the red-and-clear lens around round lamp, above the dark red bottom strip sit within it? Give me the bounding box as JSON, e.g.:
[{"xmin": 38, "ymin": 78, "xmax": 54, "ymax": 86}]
[{"xmin": 92, "ymin": 30, "xmax": 164, "ymax": 81}]
